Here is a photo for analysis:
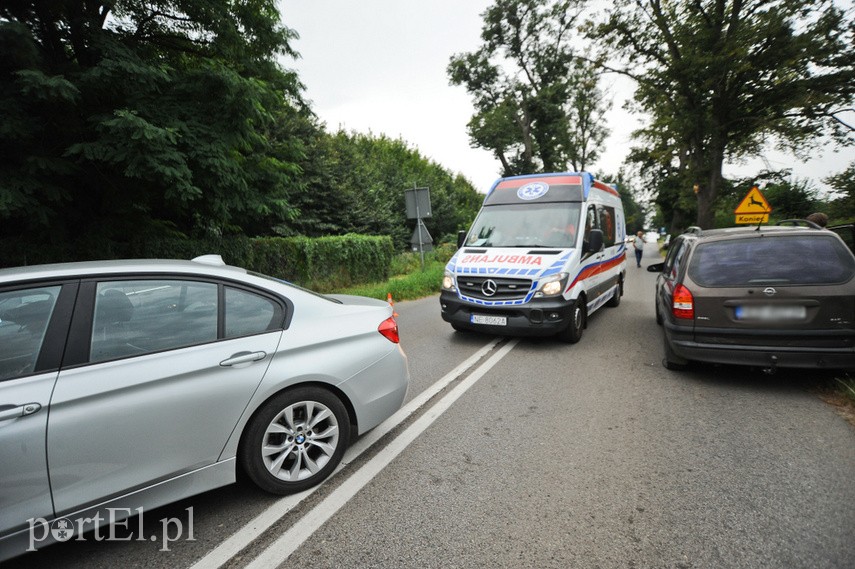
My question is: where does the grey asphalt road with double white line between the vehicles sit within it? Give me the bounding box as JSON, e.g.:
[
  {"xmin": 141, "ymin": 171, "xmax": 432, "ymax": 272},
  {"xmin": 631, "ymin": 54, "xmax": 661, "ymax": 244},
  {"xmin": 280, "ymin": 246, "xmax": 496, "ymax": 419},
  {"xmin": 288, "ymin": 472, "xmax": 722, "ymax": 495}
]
[{"xmin": 4, "ymin": 245, "xmax": 855, "ymax": 569}]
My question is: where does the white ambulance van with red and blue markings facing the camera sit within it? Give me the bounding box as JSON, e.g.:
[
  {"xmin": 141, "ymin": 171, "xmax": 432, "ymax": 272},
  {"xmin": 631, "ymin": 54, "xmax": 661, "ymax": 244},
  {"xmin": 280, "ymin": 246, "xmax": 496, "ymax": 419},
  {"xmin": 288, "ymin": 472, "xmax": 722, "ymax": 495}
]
[{"xmin": 440, "ymin": 172, "xmax": 626, "ymax": 343}]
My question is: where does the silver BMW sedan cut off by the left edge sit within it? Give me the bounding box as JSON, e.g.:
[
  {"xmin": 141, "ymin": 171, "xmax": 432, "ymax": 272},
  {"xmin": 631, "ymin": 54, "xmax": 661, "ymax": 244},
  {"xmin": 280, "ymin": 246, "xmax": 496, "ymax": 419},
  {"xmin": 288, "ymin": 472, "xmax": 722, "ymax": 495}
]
[{"xmin": 0, "ymin": 256, "xmax": 409, "ymax": 561}]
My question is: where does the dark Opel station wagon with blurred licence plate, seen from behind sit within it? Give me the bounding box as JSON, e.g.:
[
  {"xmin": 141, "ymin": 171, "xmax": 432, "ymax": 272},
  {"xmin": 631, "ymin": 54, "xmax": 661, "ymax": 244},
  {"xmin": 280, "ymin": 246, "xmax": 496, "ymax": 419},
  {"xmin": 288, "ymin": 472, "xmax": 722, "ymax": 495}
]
[{"xmin": 647, "ymin": 227, "xmax": 855, "ymax": 371}]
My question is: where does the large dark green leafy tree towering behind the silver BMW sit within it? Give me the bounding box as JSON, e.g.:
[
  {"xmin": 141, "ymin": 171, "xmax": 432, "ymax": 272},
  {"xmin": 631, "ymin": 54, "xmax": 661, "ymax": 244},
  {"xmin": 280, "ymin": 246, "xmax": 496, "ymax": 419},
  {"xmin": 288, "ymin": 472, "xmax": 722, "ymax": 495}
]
[{"xmin": 0, "ymin": 0, "xmax": 308, "ymax": 253}]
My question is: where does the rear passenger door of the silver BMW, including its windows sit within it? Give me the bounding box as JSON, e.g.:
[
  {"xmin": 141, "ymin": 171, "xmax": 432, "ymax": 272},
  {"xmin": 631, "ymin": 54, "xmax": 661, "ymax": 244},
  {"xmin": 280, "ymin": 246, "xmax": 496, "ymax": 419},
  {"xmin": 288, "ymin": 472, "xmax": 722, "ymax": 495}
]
[{"xmin": 48, "ymin": 277, "xmax": 284, "ymax": 515}]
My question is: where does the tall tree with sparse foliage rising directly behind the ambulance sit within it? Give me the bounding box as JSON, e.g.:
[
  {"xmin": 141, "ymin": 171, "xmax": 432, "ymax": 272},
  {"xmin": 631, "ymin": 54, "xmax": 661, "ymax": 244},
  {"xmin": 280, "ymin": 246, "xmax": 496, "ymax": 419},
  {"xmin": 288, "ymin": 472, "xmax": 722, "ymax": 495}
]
[{"xmin": 448, "ymin": 0, "xmax": 608, "ymax": 175}]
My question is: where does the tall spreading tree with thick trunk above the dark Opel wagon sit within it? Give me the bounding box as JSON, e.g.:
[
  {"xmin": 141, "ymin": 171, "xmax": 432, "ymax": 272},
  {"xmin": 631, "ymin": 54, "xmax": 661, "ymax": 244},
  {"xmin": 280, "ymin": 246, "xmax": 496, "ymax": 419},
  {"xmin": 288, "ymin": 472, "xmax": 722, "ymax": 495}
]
[{"xmin": 588, "ymin": 0, "xmax": 855, "ymax": 227}]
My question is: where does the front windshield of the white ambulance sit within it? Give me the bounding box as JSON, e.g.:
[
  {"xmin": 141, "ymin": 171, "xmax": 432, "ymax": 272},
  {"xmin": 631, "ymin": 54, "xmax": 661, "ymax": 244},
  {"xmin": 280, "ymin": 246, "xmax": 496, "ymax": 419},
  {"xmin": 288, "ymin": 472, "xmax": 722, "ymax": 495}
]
[{"xmin": 466, "ymin": 202, "xmax": 581, "ymax": 249}]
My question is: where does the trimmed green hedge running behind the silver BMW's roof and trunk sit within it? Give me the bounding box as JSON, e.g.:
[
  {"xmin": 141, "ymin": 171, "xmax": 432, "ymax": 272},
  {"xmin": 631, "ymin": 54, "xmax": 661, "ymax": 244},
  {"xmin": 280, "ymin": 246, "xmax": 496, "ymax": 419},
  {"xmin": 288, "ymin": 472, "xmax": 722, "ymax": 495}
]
[{"xmin": 0, "ymin": 234, "xmax": 394, "ymax": 292}]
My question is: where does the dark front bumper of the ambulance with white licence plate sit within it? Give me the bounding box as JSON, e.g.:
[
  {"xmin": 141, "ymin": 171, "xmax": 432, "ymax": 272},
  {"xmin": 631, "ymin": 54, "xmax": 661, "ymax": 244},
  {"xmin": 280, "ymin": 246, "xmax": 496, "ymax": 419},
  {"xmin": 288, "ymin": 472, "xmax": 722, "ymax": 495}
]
[{"xmin": 439, "ymin": 291, "xmax": 573, "ymax": 336}]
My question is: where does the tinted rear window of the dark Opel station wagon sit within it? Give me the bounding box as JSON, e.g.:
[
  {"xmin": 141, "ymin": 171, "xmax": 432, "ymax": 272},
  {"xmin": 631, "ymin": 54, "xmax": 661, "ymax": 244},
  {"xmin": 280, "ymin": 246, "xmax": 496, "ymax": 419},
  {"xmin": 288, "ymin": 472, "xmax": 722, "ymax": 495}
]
[{"xmin": 689, "ymin": 234, "xmax": 855, "ymax": 286}]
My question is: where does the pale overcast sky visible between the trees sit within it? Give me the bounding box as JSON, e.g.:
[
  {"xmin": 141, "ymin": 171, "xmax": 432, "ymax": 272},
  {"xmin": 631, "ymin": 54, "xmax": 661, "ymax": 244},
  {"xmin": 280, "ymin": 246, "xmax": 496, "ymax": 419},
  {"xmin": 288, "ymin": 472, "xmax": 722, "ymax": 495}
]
[{"xmin": 279, "ymin": 0, "xmax": 855, "ymax": 192}]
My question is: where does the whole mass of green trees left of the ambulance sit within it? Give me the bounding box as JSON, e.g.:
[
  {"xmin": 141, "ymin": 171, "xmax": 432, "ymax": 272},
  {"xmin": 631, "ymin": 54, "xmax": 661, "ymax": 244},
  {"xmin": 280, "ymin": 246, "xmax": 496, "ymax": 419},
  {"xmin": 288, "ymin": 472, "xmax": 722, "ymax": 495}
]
[{"xmin": 0, "ymin": 0, "xmax": 480, "ymax": 258}]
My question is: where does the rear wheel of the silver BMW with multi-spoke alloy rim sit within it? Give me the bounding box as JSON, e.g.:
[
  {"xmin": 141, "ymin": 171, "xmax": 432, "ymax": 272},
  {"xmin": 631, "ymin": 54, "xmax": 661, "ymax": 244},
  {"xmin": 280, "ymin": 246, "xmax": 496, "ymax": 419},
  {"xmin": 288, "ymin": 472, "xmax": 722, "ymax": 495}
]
[{"xmin": 239, "ymin": 387, "xmax": 350, "ymax": 494}]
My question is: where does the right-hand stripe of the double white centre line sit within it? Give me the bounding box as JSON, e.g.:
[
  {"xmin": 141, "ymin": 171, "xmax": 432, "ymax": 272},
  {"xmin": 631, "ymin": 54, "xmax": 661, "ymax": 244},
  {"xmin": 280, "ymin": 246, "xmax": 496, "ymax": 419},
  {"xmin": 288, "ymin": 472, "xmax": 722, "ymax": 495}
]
[{"xmin": 246, "ymin": 339, "xmax": 519, "ymax": 569}]
